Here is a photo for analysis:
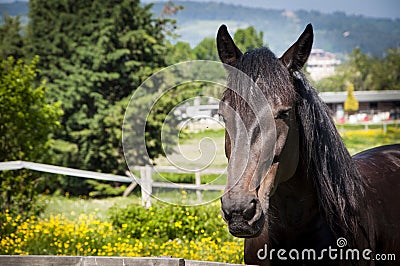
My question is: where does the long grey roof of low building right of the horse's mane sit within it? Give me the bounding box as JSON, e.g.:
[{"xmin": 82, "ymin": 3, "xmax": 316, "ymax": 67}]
[{"xmin": 319, "ymin": 90, "xmax": 400, "ymax": 103}]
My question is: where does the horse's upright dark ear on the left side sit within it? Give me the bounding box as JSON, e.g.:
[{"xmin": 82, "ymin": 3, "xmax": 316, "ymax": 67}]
[{"xmin": 217, "ymin": 25, "xmax": 243, "ymax": 66}]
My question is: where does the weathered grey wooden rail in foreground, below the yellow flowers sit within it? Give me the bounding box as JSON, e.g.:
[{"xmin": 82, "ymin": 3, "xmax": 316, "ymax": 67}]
[{"xmin": 0, "ymin": 255, "xmax": 250, "ymax": 266}]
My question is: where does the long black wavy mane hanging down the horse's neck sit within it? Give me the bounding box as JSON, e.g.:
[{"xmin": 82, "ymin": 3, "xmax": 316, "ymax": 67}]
[{"xmin": 293, "ymin": 71, "xmax": 367, "ymax": 247}]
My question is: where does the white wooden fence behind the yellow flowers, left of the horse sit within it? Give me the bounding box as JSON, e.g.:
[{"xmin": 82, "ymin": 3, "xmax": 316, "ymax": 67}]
[{"xmin": 0, "ymin": 161, "xmax": 225, "ymax": 208}]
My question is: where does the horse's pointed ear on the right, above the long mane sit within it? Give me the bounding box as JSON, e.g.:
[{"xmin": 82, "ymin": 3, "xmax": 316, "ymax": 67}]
[{"xmin": 279, "ymin": 24, "xmax": 314, "ymax": 72}]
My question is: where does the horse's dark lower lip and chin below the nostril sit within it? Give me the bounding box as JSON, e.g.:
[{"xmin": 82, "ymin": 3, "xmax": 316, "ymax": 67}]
[{"xmin": 228, "ymin": 214, "xmax": 265, "ymax": 238}]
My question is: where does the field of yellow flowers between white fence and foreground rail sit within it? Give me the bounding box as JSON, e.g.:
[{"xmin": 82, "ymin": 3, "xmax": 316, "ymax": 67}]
[{"xmin": 0, "ymin": 203, "xmax": 243, "ymax": 263}]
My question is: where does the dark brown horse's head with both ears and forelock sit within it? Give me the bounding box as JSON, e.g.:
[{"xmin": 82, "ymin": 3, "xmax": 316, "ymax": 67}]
[{"xmin": 217, "ymin": 25, "xmax": 313, "ymax": 238}]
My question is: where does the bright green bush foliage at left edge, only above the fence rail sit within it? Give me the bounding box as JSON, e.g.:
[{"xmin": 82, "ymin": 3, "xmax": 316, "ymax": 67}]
[{"xmin": 0, "ymin": 57, "xmax": 62, "ymax": 162}]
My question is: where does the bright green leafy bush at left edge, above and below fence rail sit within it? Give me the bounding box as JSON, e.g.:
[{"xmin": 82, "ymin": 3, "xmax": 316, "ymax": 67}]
[{"xmin": 0, "ymin": 57, "xmax": 62, "ymax": 221}]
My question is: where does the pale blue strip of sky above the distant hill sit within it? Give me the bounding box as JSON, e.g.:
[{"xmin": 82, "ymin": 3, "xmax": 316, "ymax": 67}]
[{"xmin": 0, "ymin": 0, "xmax": 400, "ymax": 19}]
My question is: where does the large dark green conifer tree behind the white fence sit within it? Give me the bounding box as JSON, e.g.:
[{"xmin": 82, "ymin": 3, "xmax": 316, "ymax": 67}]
[{"xmin": 27, "ymin": 0, "xmax": 171, "ymax": 174}]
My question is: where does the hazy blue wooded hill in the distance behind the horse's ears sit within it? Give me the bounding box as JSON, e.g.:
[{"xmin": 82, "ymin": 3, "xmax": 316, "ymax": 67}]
[{"xmin": 0, "ymin": 1, "xmax": 400, "ymax": 56}]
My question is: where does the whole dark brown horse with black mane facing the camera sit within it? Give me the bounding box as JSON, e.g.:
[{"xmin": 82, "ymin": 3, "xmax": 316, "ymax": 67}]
[{"xmin": 216, "ymin": 24, "xmax": 400, "ymax": 265}]
